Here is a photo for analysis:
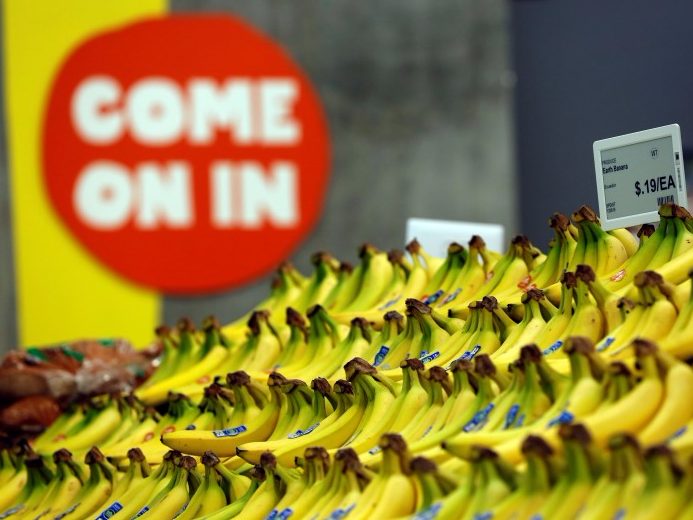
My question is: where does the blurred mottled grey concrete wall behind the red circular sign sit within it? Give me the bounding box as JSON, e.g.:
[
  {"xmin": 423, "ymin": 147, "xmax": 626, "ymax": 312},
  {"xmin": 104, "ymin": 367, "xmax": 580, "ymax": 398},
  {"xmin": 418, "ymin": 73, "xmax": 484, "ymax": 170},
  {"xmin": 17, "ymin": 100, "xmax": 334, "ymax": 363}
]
[{"xmin": 0, "ymin": 0, "xmax": 518, "ymax": 348}]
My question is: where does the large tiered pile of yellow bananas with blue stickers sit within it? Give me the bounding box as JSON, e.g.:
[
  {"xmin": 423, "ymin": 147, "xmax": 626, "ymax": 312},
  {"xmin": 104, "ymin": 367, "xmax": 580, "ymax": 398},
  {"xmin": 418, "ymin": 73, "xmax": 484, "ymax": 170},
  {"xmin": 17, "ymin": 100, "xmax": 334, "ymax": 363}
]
[{"xmin": 0, "ymin": 204, "xmax": 693, "ymax": 520}]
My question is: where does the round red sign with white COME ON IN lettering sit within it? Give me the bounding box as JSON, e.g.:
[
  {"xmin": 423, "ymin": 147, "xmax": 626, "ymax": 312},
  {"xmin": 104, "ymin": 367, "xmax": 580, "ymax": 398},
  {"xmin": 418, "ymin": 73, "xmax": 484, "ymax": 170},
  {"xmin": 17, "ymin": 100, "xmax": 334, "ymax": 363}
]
[{"xmin": 43, "ymin": 15, "xmax": 329, "ymax": 293}]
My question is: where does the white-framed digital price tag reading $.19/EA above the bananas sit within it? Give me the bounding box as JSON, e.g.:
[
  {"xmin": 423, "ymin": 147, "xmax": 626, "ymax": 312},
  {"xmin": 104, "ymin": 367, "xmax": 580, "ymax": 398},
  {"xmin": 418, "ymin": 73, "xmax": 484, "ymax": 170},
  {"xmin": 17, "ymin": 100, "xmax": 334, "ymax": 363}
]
[{"xmin": 592, "ymin": 125, "xmax": 688, "ymax": 230}]
